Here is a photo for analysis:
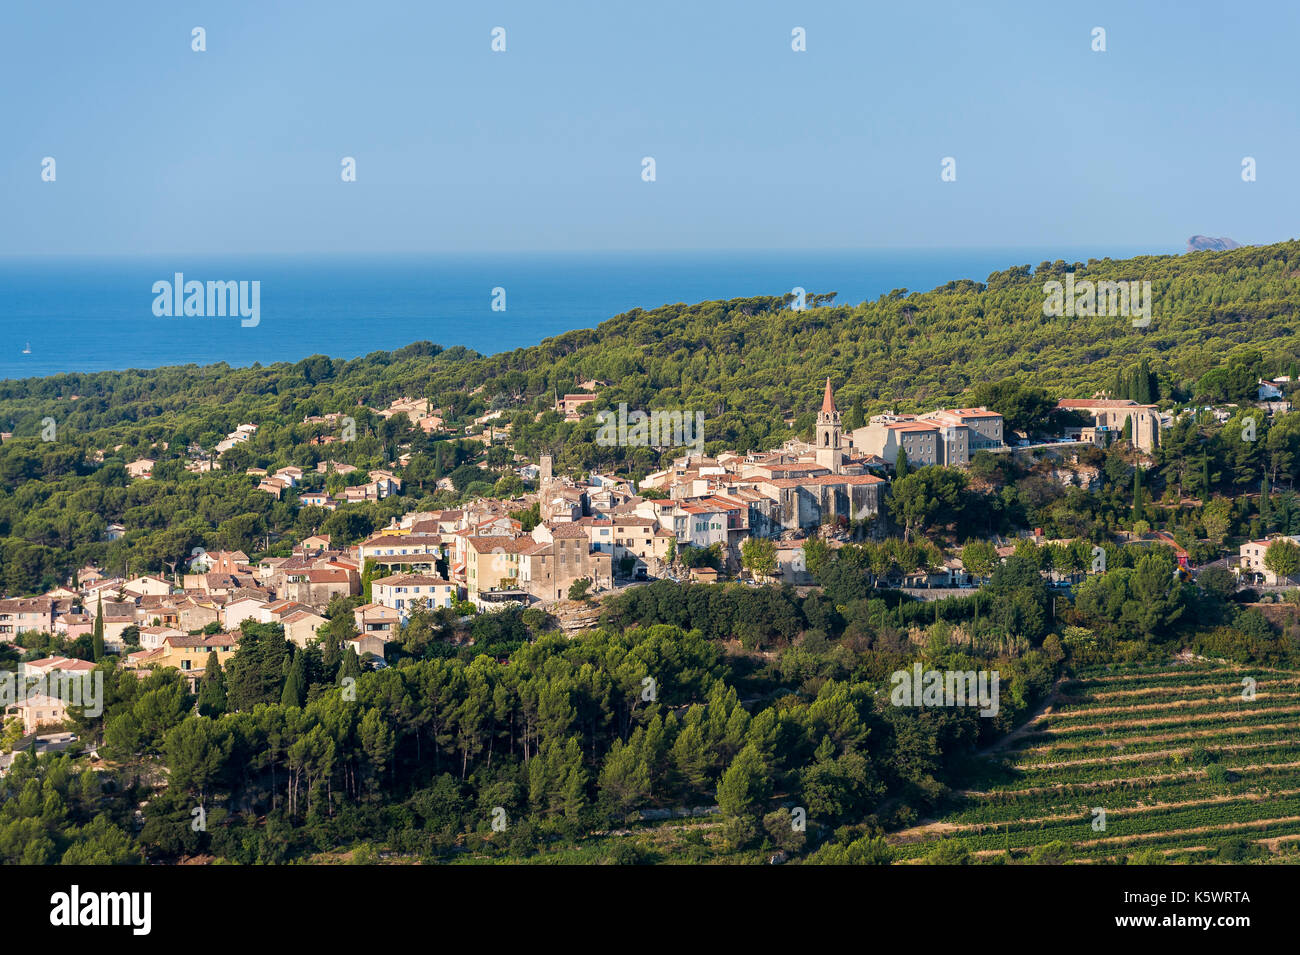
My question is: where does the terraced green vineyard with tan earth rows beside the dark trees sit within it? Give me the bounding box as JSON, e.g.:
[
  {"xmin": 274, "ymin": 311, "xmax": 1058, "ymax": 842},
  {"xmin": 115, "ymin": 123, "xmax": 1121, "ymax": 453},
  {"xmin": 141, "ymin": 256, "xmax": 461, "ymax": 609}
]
[{"xmin": 891, "ymin": 661, "xmax": 1300, "ymax": 863}]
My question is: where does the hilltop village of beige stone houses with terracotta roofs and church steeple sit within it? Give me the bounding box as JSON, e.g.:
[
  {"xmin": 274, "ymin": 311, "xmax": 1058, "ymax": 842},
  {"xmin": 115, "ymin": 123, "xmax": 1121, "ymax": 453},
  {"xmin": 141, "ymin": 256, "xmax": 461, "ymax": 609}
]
[{"xmin": 0, "ymin": 369, "xmax": 1237, "ymax": 719}]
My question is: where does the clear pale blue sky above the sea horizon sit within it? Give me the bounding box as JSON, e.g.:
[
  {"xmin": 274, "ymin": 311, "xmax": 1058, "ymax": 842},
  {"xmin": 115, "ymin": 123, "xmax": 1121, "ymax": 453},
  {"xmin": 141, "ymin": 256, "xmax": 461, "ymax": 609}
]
[{"xmin": 0, "ymin": 0, "xmax": 1300, "ymax": 255}]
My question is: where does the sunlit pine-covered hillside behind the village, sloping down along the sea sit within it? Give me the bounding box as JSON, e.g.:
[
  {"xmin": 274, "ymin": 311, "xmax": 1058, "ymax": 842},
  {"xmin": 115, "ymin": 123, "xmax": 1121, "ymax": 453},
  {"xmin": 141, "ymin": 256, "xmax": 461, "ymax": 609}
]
[{"xmin": 0, "ymin": 242, "xmax": 1300, "ymax": 447}]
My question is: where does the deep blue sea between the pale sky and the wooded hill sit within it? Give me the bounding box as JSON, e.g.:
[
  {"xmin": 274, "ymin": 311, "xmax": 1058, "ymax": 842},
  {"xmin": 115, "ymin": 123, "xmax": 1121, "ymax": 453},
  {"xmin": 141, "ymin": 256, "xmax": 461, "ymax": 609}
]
[{"xmin": 0, "ymin": 246, "xmax": 1182, "ymax": 378}]
